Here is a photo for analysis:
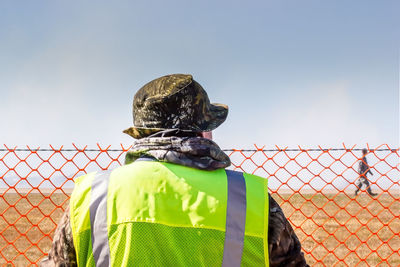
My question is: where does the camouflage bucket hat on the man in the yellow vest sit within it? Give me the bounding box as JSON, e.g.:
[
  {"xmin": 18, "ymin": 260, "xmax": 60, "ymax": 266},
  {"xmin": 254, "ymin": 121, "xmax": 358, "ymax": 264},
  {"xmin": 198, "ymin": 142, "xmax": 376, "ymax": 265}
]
[{"xmin": 124, "ymin": 74, "xmax": 228, "ymax": 139}]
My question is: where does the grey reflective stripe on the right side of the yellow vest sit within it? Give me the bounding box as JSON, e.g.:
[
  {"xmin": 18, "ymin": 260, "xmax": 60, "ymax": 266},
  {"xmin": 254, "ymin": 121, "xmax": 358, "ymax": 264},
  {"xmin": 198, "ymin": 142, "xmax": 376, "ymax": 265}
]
[{"xmin": 222, "ymin": 170, "xmax": 246, "ymax": 267}]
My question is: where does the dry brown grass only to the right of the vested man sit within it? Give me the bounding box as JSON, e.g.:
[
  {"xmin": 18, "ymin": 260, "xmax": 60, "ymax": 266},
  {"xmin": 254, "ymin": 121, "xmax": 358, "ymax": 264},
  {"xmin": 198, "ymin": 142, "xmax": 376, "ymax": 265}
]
[{"xmin": 273, "ymin": 193, "xmax": 400, "ymax": 266}]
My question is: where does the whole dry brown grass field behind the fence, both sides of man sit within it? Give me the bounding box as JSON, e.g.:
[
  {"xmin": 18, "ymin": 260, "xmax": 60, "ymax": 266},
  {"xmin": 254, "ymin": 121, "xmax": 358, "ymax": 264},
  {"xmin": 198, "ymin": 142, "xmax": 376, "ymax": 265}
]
[{"xmin": 0, "ymin": 191, "xmax": 400, "ymax": 266}]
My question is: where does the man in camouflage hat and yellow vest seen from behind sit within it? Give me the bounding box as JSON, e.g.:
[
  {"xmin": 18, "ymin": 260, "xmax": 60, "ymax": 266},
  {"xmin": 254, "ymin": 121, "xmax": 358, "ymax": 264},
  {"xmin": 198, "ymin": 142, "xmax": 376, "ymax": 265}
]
[{"xmin": 42, "ymin": 74, "xmax": 307, "ymax": 266}]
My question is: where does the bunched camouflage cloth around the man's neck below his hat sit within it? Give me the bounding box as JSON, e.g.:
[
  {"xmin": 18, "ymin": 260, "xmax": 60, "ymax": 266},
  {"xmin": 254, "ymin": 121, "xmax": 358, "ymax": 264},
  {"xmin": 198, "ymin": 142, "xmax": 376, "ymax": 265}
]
[{"xmin": 125, "ymin": 133, "xmax": 231, "ymax": 170}]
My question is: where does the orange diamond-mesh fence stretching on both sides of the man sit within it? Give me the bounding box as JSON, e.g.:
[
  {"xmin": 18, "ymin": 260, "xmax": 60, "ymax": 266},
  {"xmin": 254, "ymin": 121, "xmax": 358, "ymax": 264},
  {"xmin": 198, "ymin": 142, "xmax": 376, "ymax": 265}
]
[{"xmin": 0, "ymin": 145, "xmax": 400, "ymax": 266}]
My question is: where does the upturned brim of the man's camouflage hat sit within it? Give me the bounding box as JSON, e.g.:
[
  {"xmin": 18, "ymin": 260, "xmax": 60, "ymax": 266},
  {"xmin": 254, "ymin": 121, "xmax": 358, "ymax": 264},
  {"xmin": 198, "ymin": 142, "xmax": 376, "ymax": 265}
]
[{"xmin": 123, "ymin": 103, "xmax": 229, "ymax": 139}]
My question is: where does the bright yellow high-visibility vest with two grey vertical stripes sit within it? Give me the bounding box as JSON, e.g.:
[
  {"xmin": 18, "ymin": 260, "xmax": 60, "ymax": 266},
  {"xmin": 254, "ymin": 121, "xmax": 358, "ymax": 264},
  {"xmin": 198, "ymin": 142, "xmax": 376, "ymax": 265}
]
[{"xmin": 70, "ymin": 160, "xmax": 269, "ymax": 266}]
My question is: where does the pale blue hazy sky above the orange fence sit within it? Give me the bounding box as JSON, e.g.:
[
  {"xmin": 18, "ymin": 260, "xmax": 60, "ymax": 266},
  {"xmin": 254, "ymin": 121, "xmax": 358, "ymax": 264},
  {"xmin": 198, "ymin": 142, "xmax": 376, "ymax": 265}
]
[{"xmin": 0, "ymin": 1, "xmax": 400, "ymax": 148}]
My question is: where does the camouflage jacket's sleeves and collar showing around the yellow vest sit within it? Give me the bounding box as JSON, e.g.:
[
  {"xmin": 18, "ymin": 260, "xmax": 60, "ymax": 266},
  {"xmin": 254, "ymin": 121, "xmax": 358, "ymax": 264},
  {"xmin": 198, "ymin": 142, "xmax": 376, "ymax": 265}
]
[{"xmin": 40, "ymin": 137, "xmax": 308, "ymax": 266}]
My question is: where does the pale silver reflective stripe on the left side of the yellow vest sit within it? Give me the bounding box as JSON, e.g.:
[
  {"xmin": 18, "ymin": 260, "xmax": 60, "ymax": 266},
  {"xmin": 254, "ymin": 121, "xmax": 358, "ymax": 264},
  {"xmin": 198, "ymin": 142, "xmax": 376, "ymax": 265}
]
[{"xmin": 89, "ymin": 171, "xmax": 111, "ymax": 267}]
